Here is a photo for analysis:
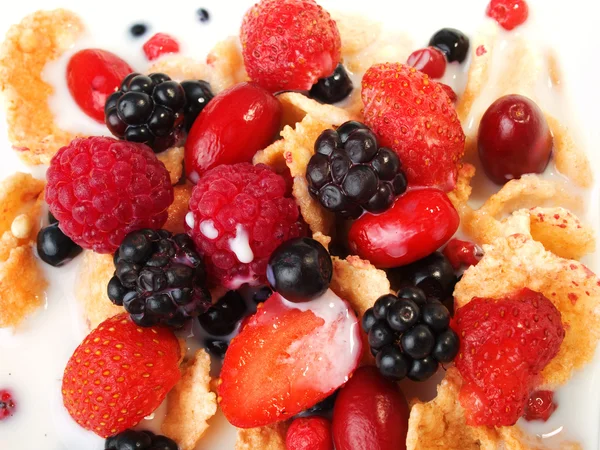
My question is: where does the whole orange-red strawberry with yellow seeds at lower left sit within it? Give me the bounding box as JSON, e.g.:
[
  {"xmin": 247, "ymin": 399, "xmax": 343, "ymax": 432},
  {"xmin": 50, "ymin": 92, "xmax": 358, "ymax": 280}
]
[{"xmin": 62, "ymin": 313, "xmax": 181, "ymax": 437}]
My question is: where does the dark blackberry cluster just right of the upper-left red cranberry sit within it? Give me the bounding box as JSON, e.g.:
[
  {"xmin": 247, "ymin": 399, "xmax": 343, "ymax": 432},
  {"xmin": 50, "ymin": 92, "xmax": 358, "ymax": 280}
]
[{"xmin": 104, "ymin": 72, "xmax": 213, "ymax": 152}]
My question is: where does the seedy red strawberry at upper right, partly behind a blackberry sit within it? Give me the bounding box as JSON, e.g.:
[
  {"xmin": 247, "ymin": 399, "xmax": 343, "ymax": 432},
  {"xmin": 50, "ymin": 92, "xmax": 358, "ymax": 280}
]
[{"xmin": 362, "ymin": 63, "xmax": 465, "ymax": 191}]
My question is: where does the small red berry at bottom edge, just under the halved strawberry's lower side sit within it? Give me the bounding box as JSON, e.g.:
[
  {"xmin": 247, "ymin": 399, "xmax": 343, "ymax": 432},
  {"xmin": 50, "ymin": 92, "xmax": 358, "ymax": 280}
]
[{"xmin": 285, "ymin": 416, "xmax": 333, "ymax": 450}]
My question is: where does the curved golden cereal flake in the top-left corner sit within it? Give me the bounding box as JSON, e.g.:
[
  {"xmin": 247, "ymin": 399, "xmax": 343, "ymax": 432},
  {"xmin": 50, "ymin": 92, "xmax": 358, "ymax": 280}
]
[{"xmin": 0, "ymin": 9, "xmax": 84, "ymax": 164}]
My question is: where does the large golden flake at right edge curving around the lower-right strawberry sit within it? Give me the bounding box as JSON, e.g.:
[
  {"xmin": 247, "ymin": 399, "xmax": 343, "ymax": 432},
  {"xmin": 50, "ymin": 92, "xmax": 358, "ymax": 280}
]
[{"xmin": 454, "ymin": 234, "xmax": 600, "ymax": 389}]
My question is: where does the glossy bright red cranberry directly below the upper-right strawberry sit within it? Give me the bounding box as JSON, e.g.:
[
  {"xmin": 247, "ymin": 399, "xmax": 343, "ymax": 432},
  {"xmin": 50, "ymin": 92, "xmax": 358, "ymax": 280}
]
[{"xmin": 348, "ymin": 188, "xmax": 459, "ymax": 268}]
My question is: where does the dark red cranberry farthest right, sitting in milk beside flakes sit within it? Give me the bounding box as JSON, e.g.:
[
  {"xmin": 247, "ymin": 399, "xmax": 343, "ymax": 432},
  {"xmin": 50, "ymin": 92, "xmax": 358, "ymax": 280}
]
[{"xmin": 477, "ymin": 95, "xmax": 552, "ymax": 184}]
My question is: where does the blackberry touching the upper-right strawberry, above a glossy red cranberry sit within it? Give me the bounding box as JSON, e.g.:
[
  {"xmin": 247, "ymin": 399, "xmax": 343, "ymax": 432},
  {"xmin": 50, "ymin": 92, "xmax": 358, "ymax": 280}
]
[{"xmin": 306, "ymin": 121, "xmax": 406, "ymax": 219}]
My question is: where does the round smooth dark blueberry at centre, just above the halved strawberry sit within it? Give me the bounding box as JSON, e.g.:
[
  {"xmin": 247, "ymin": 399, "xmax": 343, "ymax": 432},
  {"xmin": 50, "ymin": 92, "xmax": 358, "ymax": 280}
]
[{"xmin": 267, "ymin": 238, "xmax": 333, "ymax": 302}]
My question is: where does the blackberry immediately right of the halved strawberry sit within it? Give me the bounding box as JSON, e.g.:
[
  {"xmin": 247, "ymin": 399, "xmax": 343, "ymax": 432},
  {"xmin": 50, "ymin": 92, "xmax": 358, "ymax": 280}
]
[{"xmin": 362, "ymin": 287, "xmax": 459, "ymax": 381}]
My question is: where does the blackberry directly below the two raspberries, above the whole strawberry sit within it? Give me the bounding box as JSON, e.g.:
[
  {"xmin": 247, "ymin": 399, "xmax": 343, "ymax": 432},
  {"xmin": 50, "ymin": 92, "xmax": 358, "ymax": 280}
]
[{"xmin": 107, "ymin": 229, "xmax": 211, "ymax": 328}]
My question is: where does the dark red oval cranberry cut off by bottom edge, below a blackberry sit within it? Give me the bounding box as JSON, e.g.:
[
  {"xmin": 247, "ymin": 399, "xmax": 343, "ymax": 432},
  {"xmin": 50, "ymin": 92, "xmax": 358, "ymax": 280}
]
[{"xmin": 332, "ymin": 366, "xmax": 409, "ymax": 450}]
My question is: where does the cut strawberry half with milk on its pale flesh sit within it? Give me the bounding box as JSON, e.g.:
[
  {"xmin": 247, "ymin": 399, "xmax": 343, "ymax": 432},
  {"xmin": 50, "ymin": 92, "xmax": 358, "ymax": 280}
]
[{"xmin": 219, "ymin": 291, "xmax": 362, "ymax": 428}]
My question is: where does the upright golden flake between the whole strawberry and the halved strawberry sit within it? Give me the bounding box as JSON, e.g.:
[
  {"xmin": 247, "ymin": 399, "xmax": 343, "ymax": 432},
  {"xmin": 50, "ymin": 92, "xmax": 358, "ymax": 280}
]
[{"xmin": 161, "ymin": 349, "xmax": 217, "ymax": 450}]
